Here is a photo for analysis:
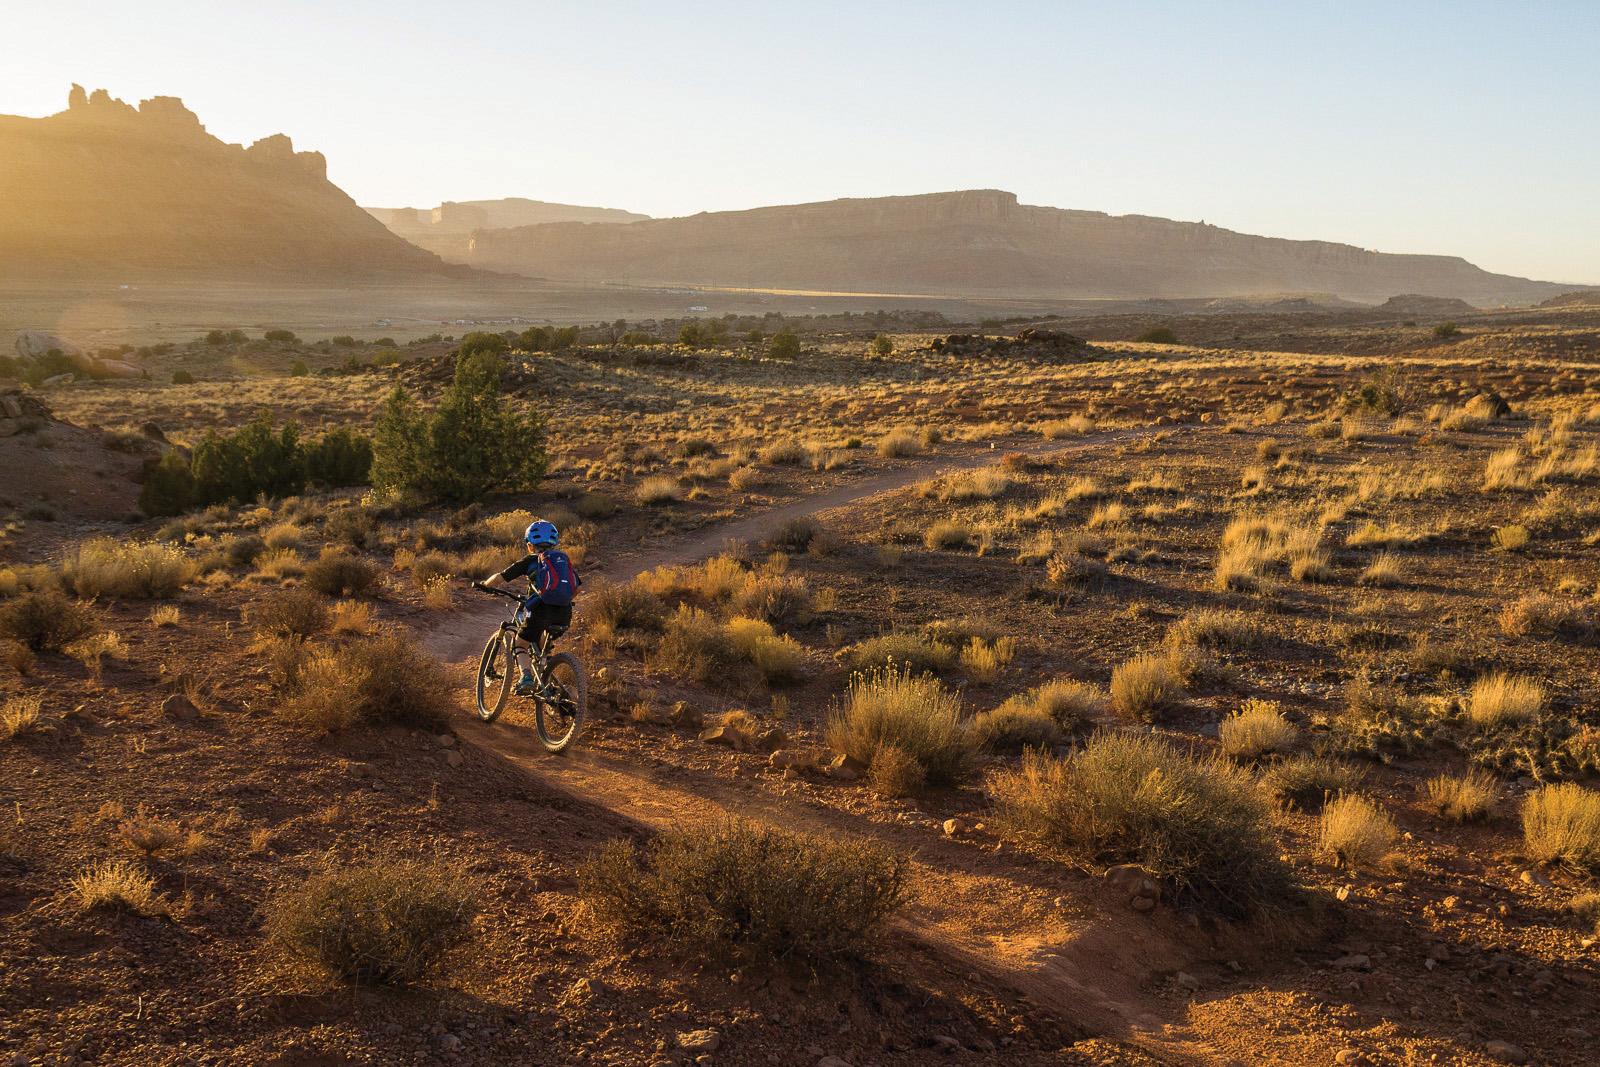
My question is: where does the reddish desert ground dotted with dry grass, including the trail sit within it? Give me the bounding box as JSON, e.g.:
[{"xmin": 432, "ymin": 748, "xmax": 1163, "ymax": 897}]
[{"xmin": 0, "ymin": 298, "xmax": 1600, "ymax": 1067}]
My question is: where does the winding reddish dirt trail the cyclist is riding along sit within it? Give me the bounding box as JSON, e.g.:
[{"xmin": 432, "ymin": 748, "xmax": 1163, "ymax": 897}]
[{"xmin": 426, "ymin": 430, "xmax": 1232, "ymax": 1064}]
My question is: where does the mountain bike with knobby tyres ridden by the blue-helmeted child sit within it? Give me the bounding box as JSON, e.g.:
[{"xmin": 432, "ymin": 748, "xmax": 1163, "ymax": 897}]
[{"xmin": 472, "ymin": 584, "xmax": 589, "ymax": 752}]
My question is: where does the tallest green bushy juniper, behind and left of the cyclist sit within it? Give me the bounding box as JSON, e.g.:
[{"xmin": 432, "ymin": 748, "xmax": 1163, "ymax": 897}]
[{"xmin": 371, "ymin": 348, "xmax": 546, "ymax": 501}]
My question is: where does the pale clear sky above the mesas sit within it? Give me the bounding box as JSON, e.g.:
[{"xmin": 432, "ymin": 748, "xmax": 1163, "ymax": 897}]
[{"xmin": 0, "ymin": 0, "xmax": 1600, "ymax": 283}]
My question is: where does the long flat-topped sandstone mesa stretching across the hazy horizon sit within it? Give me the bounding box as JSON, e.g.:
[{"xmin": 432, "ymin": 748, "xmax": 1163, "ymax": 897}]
[{"xmin": 469, "ymin": 189, "xmax": 1571, "ymax": 306}]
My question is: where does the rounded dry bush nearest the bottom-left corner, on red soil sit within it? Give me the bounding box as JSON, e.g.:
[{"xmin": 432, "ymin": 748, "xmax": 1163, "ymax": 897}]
[{"xmin": 264, "ymin": 859, "xmax": 478, "ymax": 982}]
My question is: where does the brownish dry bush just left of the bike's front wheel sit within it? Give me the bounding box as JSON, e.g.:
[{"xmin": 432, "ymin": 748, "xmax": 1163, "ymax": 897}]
[{"xmin": 278, "ymin": 632, "xmax": 454, "ymax": 733}]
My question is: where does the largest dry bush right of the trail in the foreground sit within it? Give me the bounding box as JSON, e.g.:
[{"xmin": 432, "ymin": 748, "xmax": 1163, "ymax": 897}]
[{"xmin": 989, "ymin": 734, "xmax": 1294, "ymax": 917}]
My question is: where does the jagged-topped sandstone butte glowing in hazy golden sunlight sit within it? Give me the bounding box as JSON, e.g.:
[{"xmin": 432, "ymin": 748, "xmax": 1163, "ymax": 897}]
[{"xmin": 0, "ymin": 86, "xmax": 462, "ymax": 282}]
